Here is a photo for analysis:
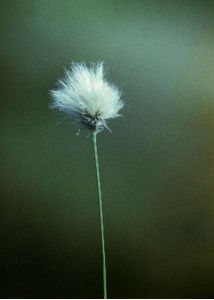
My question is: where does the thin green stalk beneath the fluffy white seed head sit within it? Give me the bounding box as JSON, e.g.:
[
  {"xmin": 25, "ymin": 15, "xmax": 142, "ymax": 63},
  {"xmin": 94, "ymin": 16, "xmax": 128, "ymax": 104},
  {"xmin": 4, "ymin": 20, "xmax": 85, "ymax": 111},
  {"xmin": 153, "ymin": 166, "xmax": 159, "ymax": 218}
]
[{"xmin": 92, "ymin": 133, "xmax": 107, "ymax": 299}]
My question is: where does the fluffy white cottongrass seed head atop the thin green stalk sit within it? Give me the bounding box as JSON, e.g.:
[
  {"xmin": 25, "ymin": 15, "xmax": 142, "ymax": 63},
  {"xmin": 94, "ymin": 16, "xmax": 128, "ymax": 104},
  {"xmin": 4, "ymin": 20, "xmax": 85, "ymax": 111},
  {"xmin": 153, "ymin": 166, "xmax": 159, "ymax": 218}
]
[{"xmin": 50, "ymin": 63, "xmax": 124, "ymax": 133}]
